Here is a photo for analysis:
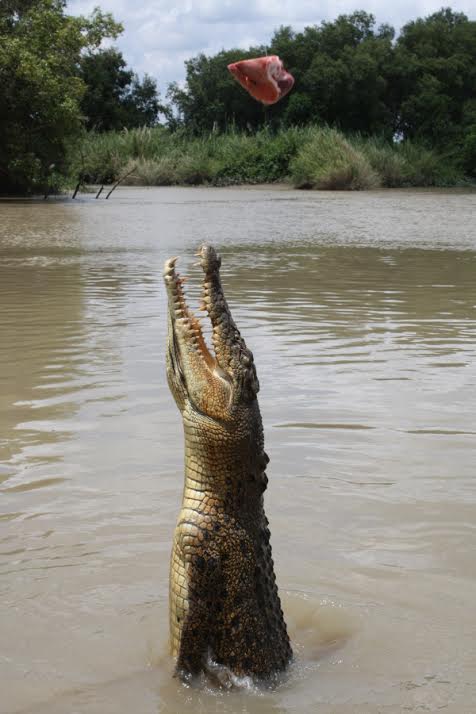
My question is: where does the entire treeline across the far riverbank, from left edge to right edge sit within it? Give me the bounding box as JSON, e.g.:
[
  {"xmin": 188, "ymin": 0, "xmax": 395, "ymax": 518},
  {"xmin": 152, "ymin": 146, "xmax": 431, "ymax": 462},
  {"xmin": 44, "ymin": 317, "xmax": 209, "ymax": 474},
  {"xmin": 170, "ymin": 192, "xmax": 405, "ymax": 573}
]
[{"xmin": 0, "ymin": 0, "xmax": 476, "ymax": 193}]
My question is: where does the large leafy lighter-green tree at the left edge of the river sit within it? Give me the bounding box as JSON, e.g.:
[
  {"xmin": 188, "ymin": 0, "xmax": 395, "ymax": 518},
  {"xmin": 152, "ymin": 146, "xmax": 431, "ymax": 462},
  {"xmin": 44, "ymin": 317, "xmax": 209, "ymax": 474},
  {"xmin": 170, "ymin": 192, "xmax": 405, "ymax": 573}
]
[{"xmin": 0, "ymin": 0, "xmax": 122, "ymax": 193}]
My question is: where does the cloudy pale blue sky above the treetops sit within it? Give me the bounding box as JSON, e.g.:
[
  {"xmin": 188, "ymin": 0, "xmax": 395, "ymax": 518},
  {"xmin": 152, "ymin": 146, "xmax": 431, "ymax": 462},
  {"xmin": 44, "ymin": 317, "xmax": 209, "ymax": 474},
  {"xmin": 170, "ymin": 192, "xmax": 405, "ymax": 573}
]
[{"xmin": 68, "ymin": 0, "xmax": 476, "ymax": 94}]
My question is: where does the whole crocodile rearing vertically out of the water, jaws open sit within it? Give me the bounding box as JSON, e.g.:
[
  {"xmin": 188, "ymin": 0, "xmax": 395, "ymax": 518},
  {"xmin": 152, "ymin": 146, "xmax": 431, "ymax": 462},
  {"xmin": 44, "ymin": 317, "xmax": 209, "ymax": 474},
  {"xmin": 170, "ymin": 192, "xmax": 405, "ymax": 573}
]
[{"xmin": 164, "ymin": 245, "xmax": 292, "ymax": 681}]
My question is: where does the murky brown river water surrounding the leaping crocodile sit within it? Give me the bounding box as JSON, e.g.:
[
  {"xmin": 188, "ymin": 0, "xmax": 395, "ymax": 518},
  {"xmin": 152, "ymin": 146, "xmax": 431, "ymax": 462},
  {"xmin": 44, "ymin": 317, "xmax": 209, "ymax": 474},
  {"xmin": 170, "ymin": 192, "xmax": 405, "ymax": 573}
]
[{"xmin": 0, "ymin": 189, "xmax": 476, "ymax": 714}]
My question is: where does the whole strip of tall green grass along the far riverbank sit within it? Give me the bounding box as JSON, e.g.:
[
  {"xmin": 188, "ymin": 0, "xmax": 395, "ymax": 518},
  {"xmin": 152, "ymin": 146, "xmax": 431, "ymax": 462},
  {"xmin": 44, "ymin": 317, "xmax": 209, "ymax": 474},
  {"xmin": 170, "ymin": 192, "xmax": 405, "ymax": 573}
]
[{"xmin": 71, "ymin": 127, "xmax": 465, "ymax": 190}]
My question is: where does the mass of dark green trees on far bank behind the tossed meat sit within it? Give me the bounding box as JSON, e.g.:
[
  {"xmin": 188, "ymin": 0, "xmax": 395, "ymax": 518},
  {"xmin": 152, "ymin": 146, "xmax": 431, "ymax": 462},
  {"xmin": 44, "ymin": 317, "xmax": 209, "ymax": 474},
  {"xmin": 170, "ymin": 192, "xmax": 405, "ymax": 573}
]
[{"xmin": 163, "ymin": 8, "xmax": 476, "ymax": 177}]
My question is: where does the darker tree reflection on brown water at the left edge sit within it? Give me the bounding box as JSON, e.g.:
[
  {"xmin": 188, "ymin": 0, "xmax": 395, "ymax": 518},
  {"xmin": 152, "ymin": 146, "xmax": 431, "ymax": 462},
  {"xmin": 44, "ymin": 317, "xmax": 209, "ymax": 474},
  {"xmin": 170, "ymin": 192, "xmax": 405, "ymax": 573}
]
[{"xmin": 0, "ymin": 261, "xmax": 83, "ymax": 472}]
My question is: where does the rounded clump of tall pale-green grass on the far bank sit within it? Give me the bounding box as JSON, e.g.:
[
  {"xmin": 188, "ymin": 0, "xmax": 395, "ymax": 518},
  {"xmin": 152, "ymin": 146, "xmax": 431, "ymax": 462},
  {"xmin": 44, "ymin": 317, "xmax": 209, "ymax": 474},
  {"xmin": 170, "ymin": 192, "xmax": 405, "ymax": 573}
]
[{"xmin": 291, "ymin": 128, "xmax": 380, "ymax": 190}]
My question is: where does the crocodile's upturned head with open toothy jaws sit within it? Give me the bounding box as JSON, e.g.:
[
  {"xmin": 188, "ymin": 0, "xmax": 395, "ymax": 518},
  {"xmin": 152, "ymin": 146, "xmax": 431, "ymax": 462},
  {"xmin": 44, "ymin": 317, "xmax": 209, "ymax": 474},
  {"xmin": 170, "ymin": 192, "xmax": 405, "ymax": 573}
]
[{"xmin": 164, "ymin": 245, "xmax": 259, "ymax": 422}]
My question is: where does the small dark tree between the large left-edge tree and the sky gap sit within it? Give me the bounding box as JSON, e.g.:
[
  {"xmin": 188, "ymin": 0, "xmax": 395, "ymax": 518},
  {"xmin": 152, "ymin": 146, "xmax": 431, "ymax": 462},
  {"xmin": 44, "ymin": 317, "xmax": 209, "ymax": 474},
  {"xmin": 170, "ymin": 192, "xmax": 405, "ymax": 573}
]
[{"xmin": 80, "ymin": 48, "xmax": 161, "ymax": 131}]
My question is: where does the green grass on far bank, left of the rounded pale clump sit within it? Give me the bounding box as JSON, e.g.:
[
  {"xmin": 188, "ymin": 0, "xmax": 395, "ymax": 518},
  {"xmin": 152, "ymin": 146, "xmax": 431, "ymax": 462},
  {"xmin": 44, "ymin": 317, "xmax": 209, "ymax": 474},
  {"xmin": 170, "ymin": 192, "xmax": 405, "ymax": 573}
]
[{"xmin": 75, "ymin": 127, "xmax": 307, "ymax": 185}]
